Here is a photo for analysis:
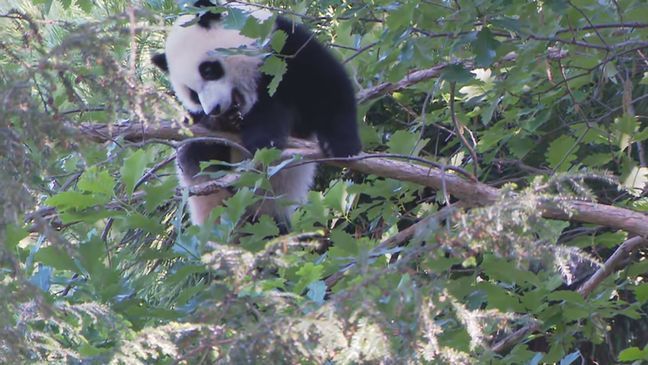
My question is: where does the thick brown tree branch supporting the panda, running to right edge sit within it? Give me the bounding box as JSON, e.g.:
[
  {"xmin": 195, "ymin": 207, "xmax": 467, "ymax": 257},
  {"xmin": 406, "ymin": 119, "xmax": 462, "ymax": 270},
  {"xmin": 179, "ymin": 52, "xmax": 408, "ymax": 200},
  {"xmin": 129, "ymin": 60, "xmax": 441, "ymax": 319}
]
[{"xmin": 74, "ymin": 123, "xmax": 648, "ymax": 237}]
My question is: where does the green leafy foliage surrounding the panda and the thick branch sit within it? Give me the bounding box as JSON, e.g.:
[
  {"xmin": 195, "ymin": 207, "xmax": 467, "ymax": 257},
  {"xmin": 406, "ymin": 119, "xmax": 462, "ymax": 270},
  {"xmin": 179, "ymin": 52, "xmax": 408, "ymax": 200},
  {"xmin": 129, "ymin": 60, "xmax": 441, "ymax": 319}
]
[{"xmin": 0, "ymin": 0, "xmax": 648, "ymax": 364}]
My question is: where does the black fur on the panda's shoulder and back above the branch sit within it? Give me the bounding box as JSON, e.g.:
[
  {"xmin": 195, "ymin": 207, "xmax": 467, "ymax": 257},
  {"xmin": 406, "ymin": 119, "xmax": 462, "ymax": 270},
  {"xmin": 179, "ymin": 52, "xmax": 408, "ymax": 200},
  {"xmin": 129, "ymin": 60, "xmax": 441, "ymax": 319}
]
[{"xmin": 241, "ymin": 17, "xmax": 362, "ymax": 157}]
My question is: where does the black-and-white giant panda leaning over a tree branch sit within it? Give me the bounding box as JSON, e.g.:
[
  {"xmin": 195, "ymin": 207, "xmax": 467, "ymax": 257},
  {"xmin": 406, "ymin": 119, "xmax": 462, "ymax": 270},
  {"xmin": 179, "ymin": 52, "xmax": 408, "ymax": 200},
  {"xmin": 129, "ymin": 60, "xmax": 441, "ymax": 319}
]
[{"xmin": 152, "ymin": 0, "xmax": 361, "ymax": 229}]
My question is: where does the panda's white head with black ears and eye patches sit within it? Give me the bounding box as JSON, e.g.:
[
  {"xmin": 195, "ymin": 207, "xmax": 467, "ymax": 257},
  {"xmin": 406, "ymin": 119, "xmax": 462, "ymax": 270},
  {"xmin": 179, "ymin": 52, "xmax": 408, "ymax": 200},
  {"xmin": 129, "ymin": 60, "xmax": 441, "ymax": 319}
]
[{"xmin": 152, "ymin": 4, "xmax": 269, "ymax": 115}]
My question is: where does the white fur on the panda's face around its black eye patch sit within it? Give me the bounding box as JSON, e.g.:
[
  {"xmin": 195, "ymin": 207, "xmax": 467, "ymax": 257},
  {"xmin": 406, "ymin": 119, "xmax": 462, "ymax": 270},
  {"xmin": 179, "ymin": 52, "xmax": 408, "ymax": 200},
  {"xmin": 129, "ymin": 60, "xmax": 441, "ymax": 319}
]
[{"xmin": 165, "ymin": 15, "xmax": 261, "ymax": 114}]
